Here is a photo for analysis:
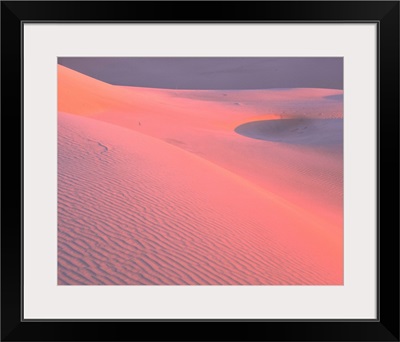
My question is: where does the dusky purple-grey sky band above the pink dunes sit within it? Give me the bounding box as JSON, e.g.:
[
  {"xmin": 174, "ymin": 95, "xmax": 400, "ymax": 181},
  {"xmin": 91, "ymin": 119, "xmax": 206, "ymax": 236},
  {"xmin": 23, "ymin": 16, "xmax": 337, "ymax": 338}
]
[{"xmin": 58, "ymin": 57, "xmax": 343, "ymax": 90}]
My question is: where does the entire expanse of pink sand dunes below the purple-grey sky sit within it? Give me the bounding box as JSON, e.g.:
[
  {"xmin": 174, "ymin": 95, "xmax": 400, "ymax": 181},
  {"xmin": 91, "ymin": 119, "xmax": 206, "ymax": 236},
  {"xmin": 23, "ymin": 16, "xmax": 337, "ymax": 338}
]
[{"xmin": 58, "ymin": 66, "xmax": 343, "ymax": 285}]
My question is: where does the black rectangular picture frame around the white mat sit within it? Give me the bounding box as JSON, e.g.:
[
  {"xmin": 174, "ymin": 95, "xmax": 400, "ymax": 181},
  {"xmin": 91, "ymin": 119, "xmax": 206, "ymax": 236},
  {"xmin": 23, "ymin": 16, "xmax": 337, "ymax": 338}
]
[{"xmin": 1, "ymin": 1, "xmax": 399, "ymax": 341}]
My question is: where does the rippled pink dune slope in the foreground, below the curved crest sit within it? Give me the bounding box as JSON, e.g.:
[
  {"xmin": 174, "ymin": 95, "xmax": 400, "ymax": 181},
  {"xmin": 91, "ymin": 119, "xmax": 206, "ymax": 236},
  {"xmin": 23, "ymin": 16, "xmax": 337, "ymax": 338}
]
[{"xmin": 59, "ymin": 114, "xmax": 341, "ymax": 284}]
